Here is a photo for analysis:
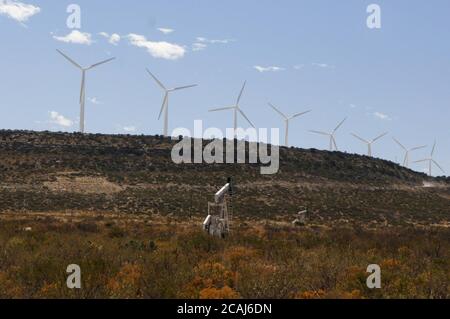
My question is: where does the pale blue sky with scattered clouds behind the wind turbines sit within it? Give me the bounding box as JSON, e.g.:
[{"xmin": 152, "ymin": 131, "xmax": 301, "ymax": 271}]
[{"xmin": 0, "ymin": 0, "xmax": 450, "ymax": 173}]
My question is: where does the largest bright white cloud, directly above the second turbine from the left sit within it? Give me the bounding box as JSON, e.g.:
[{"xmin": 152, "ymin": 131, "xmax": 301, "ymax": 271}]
[{"xmin": 127, "ymin": 33, "xmax": 186, "ymax": 60}]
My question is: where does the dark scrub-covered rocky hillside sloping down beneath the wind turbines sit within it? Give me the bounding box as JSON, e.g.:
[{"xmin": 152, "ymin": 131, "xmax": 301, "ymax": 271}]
[{"xmin": 0, "ymin": 131, "xmax": 450, "ymax": 225}]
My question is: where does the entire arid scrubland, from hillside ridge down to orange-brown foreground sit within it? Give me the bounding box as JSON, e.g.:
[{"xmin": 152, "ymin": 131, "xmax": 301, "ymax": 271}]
[{"xmin": 0, "ymin": 131, "xmax": 450, "ymax": 298}]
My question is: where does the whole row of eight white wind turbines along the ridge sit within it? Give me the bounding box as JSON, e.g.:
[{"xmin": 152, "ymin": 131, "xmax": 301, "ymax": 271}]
[{"xmin": 57, "ymin": 50, "xmax": 445, "ymax": 176}]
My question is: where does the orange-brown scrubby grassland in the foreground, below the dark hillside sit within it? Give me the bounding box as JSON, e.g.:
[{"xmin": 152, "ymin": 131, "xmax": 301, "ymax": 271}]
[{"xmin": 0, "ymin": 212, "xmax": 450, "ymax": 299}]
